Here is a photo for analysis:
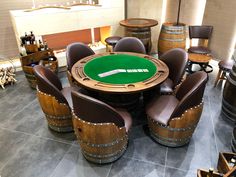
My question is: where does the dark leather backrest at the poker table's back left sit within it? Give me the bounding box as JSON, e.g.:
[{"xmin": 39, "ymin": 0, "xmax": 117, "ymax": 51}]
[{"xmin": 66, "ymin": 42, "xmax": 95, "ymax": 71}]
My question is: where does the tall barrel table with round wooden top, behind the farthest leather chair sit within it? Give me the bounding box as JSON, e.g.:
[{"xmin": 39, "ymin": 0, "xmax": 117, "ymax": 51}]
[{"xmin": 120, "ymin": 18, "xmax": 158, "ymax": 53}]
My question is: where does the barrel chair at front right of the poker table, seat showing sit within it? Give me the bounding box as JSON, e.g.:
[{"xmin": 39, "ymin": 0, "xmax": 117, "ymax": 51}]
[{"xmin": 146, "ymin": 71, "xmax": 207, "ymax": 147}]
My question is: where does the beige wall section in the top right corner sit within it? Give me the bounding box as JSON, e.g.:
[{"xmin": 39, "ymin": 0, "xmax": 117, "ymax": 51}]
[{"xmin": 203, "ymin": 0, "xmax": 236, "ymax": 60}]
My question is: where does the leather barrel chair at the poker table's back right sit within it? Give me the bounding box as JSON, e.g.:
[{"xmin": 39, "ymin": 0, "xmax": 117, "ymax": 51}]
[{"xmin": 160, "ymin": 48, "xmax": 188, "ymax": 94}]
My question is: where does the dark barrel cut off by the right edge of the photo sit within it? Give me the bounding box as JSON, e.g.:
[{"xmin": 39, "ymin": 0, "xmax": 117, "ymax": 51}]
[{"xmin": 222, "ymin": 62, "xmax": 236, "ymax": 122}]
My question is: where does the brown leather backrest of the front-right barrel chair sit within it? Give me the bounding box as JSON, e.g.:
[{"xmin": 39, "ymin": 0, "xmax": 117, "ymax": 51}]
[{"xmin": 171, "ymin": 71, "xmax": 208, "ymax": 118}]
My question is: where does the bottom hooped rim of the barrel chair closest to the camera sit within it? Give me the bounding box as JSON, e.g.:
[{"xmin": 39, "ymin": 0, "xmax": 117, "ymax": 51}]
[{"xmin": 82, "ymin": 146, "xmax": 127, "ymax": 164}]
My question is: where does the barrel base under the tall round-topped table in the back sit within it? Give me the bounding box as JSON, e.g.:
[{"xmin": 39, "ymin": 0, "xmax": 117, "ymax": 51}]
[{"xmin": 125, "ymin": 27, "xmax": 152, "ymax": 53}]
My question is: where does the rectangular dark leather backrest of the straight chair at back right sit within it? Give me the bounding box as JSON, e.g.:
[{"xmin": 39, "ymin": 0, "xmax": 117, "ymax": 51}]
[{"xmin": 189, "ymin": 26, "xmax": 213, "ymax": 39}]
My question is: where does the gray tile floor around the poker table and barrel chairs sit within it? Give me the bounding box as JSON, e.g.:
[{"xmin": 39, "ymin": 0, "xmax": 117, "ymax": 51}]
[{"xmin": 0, "ymin": 61, "xmax": 233, "ymax": 177}]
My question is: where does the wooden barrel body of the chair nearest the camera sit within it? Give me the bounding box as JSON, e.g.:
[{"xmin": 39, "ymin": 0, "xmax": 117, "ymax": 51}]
[{"xmin": 72, "ymin": 113, "xmax": 128, "ymax": 164}]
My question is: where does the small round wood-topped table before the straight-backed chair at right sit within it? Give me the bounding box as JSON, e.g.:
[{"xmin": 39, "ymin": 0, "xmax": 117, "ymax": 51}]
[{"xmin": 187, "ymin": 53, "xmax": 213, "ymax": 73}]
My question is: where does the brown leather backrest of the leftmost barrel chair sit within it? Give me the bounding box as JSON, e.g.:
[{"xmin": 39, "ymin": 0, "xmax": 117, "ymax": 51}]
[{"xmin": 33, "ymin": 65, "xmax": 68, "ymax": 104}]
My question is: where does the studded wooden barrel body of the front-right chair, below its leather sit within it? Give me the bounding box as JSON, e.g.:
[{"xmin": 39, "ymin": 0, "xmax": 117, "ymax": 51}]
[{"xmin": 148, "ymin": 104, "xmax": 203, "ymax": 147}]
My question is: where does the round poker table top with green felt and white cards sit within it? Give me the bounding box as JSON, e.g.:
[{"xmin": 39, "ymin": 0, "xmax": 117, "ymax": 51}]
[{"xmin": 72, "ymin": 52, "xmax": 169, "ymax": 94}]
